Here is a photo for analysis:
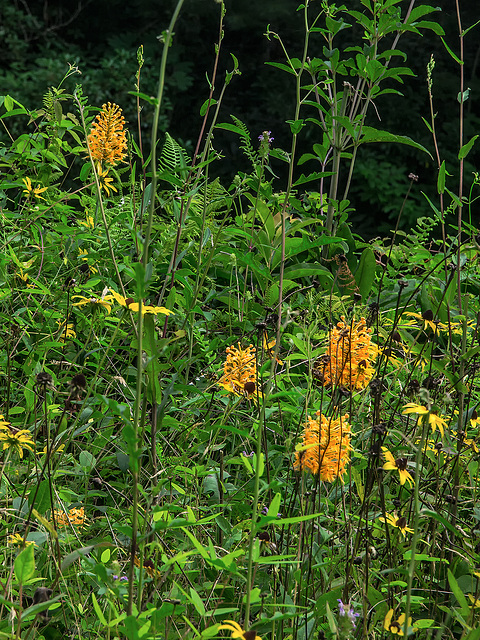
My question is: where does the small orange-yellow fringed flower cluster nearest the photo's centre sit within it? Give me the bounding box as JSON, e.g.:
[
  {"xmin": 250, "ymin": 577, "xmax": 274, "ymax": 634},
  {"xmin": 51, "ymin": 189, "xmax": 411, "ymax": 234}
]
[{"xmin": 218, "ymin": 343, "xmax": 257, "ymax": 396}]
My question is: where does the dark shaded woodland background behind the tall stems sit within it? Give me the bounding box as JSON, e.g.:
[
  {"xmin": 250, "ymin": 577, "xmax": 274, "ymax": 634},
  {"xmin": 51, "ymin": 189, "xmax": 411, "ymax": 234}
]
[{"xmin": 0, "ymin": 0, "xmax": 480, "ymax": 237}]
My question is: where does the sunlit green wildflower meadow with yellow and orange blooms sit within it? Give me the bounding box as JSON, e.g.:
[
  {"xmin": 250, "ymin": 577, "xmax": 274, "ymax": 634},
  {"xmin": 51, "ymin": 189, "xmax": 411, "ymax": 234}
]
[{"xmin": 0, "ymin": 0, "xmax": 480, "ymax": 640}]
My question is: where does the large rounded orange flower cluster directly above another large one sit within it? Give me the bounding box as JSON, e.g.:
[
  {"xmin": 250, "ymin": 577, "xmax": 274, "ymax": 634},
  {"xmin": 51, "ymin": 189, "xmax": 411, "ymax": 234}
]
[{"xmin": 319, "ymin": 316, "xmax": 378, "ymax": 389}]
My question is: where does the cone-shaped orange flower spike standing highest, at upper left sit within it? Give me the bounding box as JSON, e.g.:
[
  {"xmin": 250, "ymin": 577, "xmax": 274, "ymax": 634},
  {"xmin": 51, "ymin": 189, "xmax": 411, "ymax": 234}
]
[{"xmin": 88, "ymin": 102, "xmax": 127, "ymax": 167}]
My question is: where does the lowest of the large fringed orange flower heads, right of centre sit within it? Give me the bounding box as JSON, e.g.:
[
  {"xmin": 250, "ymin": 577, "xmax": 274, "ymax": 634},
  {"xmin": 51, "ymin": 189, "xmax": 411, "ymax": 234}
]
[{"xmin": 293, "ymin": 411, "xmax": 352, "ymax": 482}]
